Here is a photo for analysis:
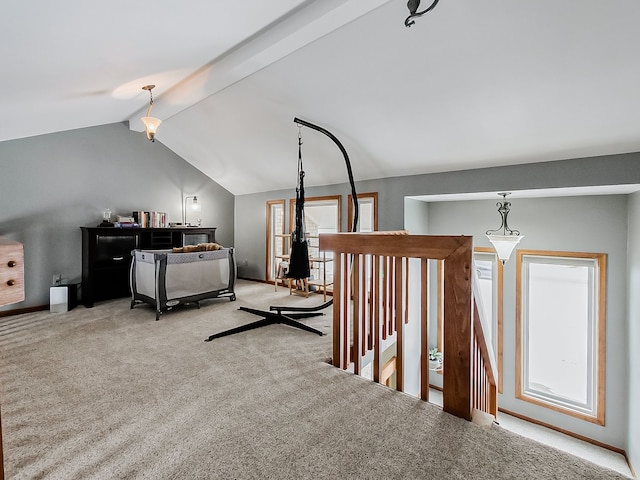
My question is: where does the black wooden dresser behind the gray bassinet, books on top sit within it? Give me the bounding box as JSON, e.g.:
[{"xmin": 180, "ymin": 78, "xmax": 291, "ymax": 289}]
[{"xmin": 80, "ymin": 227, "xmax": 216, "ymax": 307}]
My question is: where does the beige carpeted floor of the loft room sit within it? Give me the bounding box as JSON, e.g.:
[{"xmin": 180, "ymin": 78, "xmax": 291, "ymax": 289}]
[{"xmin": 0, "ymin": 281, "xmax": 626, "ymax": 479}]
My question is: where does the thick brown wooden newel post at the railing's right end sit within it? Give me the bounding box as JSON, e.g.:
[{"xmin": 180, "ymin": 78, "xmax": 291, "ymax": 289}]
[{"xmin": 443, "ymin": 237, "xmax": 473, "ymax": 420}]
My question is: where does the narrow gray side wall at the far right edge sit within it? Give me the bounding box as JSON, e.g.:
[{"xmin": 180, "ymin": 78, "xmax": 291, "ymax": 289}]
[{"xmin": 627, "ymin": 192, "xmax": 640, "ymax": 472}]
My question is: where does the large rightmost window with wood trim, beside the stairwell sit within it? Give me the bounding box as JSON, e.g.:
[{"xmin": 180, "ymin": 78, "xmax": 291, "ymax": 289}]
[{"xmin": 516, "ymin": 250, "xmax": 606, "ymax": 425}]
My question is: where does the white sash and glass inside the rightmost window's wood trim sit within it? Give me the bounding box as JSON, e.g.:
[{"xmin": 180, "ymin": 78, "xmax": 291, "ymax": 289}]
[{"xmin": 523, "ymin": 256, "xmax": 598, "ymax": 413}]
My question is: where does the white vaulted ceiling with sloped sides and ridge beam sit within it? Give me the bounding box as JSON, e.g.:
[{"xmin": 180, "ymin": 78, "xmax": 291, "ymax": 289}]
[{"xmin": 0, "ymin": 0, "xmax": 640, "ymax": 194}]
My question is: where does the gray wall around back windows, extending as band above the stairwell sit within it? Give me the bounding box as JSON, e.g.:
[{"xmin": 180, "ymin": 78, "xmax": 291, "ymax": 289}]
[{"xmin": 235, "ymin": 153, "xmax": 640, "ymax": 280}]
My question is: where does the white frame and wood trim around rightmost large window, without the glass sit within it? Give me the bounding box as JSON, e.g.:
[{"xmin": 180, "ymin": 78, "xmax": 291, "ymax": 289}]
[{"xmin": 516, "ymin": 250, "xmax": 606, "ymax": 425}]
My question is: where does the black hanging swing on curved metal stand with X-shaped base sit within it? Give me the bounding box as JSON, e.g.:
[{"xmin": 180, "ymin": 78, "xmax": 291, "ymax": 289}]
[{"xmin": 205, "ymin": 118, "xmax": 358, "ymax": 342}]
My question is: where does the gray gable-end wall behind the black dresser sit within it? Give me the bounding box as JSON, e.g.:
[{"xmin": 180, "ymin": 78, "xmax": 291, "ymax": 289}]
[{"xmin": 0, "ymin": 123, "xmax": 234, "ymax": 310}]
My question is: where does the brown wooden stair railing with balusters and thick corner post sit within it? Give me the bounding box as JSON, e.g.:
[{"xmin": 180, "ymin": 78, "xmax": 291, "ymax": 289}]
[{"xmin": 320, "ymin": 232, "xmax": 497, "ymax": 420}]
